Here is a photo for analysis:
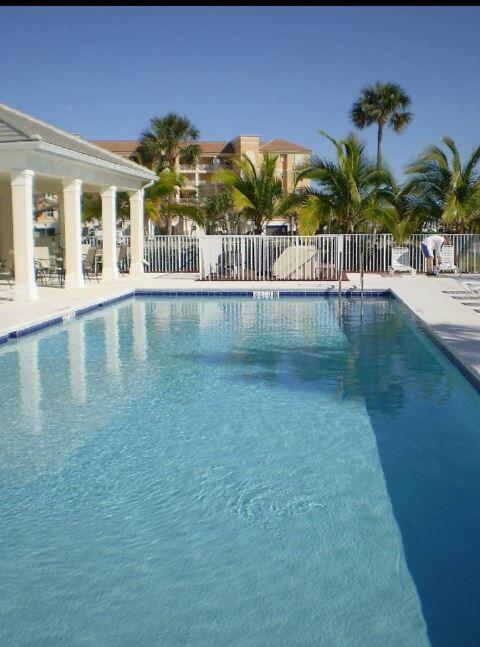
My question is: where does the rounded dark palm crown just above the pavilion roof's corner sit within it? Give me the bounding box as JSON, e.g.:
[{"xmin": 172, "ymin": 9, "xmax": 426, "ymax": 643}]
[{"xmin": 134, "ymin": 112, "xmax": 200, "ymax": 173}]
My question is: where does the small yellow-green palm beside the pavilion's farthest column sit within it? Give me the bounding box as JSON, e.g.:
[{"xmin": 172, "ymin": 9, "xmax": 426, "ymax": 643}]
[{"xmin": 145, "ymin": 169, "xmax": 205, "ymax": 235}]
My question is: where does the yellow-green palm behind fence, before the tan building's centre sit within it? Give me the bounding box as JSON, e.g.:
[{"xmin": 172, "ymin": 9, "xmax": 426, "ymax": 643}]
[{"xmin": 213, "ymin": 154, "xmax": 283, "ymax": 234}]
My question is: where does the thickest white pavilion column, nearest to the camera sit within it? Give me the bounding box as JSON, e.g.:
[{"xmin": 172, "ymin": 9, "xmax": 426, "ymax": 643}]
[{"xmin": 11, "ymin": 170, "xmax": 38, "ymax": 301}]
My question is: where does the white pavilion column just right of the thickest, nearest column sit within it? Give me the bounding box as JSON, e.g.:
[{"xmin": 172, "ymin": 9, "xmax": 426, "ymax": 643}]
[{"xmin": 63, "ymin": 180, "xmax": 84, "ymax": 288}]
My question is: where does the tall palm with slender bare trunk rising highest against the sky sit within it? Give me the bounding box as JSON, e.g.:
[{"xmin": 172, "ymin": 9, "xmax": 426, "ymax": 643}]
[{"xmin": 350, "ymin": 81, "xmax": 413, "ymax": 170}]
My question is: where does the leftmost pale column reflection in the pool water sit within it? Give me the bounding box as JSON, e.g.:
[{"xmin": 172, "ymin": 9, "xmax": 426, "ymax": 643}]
[{"xmin": 17, "ymin": 340, "xmax": 42, "ymax": 434}]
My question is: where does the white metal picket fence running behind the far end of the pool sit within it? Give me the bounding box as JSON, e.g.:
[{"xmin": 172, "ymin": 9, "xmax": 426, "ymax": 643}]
[{"xmin": 82, "ymin": 234, "xmax": 480, "ymax": 281}]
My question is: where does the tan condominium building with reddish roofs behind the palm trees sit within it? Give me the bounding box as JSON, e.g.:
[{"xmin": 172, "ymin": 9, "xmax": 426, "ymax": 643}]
[{"xmin": 92, "ymin": 135, "xmax": 312, "ymax": 233}]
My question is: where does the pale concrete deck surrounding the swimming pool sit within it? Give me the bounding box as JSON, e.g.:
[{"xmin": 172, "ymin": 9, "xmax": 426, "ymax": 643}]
[{"xmin": 0, "ymin": 274, "xmax": 480, "ymax": 381}]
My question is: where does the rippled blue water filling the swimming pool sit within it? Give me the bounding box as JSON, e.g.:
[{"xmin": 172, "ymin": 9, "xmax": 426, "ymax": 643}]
[{"xmin": 0, "ymin": 298, "xmax": 480, "ymax": 647}]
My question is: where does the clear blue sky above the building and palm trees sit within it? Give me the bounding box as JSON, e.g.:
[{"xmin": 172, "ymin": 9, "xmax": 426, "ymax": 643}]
[{"xmin": 0, "ymin": 7, "xmax": 480, "ymax": 175}]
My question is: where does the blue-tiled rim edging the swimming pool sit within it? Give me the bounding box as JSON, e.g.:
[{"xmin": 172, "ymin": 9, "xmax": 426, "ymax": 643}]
[{"xmin": 0, "ymin": 287, "xmax": 480, "ymax": 392}]
